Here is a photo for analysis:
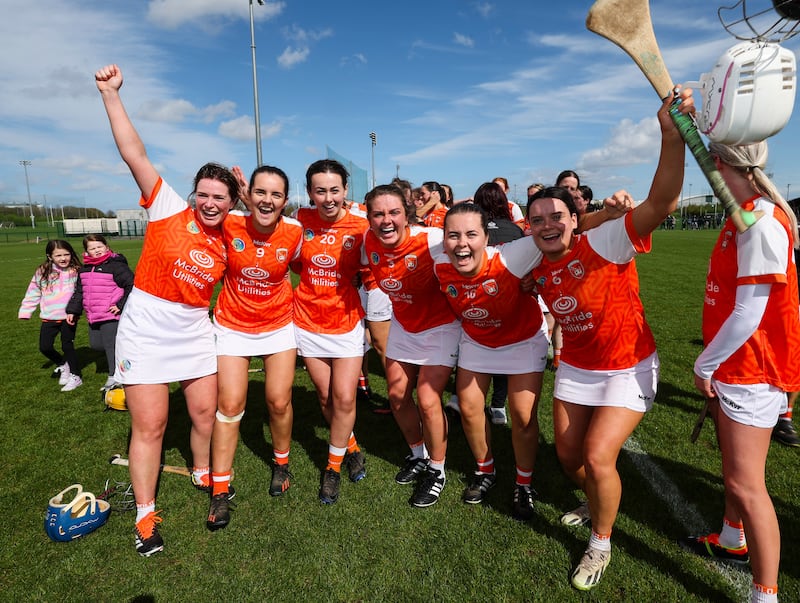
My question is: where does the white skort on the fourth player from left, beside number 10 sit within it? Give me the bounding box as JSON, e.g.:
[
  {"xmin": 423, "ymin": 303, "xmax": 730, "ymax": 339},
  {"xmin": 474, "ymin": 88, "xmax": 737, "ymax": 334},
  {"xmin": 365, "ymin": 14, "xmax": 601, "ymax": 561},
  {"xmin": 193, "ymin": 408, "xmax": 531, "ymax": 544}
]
[{"xmin": 386, "ymin": 318, "xmax": 461, "ymax": 367}]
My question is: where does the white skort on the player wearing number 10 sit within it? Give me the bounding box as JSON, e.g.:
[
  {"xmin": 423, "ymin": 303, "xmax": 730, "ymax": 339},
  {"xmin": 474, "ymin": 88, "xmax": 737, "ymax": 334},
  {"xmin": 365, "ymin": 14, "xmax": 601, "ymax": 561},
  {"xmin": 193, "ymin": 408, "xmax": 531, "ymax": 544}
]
[{"xmin": 458, "ymin": 321, "xmax": 549, "ymax": 375}]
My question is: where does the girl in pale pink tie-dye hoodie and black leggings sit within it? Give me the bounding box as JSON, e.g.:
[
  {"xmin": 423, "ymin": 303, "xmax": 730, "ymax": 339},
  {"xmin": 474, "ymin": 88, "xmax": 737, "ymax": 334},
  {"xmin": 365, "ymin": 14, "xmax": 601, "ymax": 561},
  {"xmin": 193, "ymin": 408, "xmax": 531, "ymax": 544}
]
[{"xmin": 18, "ymin": 239, "xmax": 83, "ymax": 392}]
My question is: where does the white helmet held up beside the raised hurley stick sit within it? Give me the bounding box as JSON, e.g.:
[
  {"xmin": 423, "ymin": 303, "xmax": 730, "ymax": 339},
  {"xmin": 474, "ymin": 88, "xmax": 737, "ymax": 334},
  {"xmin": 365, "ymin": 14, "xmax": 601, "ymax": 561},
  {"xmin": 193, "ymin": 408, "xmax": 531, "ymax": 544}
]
[{"xmin": 686, "ymin": 41, "xmax": 797, "ymax": 144}]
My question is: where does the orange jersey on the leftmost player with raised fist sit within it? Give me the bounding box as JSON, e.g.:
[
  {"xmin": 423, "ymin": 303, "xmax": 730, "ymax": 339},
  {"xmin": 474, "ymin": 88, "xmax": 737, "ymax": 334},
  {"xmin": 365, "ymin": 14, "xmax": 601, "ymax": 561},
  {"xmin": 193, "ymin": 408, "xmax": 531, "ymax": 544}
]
[{"xmin": 133, "ymin": 178, "xmax": 226, "ymax": 307}]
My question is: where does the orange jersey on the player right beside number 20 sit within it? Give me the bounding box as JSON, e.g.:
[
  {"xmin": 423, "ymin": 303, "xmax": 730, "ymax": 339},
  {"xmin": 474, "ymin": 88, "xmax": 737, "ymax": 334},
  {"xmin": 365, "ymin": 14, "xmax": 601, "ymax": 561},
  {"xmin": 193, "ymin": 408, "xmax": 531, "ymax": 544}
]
[{"xmin": 364, "ymin": 226, "xmax": 456, "ymax": 333}]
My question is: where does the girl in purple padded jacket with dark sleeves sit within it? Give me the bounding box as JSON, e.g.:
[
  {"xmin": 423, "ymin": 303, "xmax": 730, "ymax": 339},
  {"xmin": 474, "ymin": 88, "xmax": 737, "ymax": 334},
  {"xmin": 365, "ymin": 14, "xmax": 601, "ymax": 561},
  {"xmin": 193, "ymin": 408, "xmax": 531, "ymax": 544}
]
[{"xmin": 67, "ymin": 234, "xmax": 133, "ymax": 391}]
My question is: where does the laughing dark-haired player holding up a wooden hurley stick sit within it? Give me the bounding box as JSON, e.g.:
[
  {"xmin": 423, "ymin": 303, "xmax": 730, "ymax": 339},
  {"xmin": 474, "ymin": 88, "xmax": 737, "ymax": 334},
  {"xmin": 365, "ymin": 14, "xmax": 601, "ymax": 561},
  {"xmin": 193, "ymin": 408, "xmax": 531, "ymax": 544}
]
[{"xmin": 528, "ymin": 90, "xmax": 694, "ymax": 590}]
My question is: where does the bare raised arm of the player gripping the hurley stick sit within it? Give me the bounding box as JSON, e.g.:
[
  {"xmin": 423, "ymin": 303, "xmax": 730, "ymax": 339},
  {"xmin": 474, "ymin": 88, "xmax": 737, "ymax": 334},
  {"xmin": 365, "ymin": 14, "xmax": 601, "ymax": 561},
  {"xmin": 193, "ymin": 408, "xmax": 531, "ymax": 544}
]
[{"xmin": 632, "ymin": 88, "xmax": 694, "ymax": 237}]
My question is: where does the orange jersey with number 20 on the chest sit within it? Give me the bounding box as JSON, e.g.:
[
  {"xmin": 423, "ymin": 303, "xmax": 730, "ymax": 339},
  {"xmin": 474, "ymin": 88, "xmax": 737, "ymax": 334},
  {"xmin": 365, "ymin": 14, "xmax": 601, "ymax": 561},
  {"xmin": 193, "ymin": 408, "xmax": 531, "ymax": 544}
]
[{"xmin": 293, "ymin": 207, "xmax": 368, "ymax": 335}]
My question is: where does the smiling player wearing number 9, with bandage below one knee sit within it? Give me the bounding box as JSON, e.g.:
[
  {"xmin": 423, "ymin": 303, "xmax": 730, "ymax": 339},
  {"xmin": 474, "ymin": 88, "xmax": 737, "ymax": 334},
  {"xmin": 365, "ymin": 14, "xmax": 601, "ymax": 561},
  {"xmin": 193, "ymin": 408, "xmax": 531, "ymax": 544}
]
[{"xmin": 206, "ymin": 165, "xmax": 303, "ymax": 530}]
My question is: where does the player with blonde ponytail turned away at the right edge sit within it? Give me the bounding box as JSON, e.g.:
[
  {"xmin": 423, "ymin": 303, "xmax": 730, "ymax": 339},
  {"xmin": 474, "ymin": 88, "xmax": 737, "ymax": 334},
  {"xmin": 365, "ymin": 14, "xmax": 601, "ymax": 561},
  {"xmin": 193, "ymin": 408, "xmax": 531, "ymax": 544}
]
[{"xmin": 681, "ymin": 142, "xmax": 800, "ymax": 602}]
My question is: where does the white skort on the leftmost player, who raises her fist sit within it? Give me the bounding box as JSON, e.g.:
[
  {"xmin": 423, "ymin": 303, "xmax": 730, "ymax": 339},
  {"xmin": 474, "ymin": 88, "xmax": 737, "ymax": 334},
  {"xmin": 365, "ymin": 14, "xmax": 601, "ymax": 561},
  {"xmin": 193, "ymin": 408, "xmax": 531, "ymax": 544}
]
[{"xmin": 114, "ymin": 287, "xmax": 217, "ymax": 385}]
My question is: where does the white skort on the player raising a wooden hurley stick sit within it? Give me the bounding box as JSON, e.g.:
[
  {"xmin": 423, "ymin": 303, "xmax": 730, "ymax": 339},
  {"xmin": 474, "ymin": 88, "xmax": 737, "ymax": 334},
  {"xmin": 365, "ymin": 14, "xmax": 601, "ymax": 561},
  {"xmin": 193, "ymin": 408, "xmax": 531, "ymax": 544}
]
[{"xmin": 553, "ymin": 352, "xmax": 659, "ymax": 412}]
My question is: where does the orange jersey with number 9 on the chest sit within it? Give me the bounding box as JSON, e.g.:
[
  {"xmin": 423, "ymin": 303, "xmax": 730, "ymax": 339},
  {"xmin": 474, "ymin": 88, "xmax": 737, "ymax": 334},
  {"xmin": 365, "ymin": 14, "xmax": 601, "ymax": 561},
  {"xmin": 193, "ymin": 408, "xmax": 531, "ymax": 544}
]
[{"xmin": 214, "ymin": 211, "xmax": 303, "ymax": 333}]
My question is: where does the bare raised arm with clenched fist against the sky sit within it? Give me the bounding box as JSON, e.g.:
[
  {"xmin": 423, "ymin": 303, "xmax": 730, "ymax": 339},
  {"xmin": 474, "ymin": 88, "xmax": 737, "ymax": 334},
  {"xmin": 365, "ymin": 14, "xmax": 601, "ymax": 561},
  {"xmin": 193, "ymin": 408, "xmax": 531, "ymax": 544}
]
[{"xmin": 94, "ymin": 65, "xmax": 159, "ymax": 198}]
